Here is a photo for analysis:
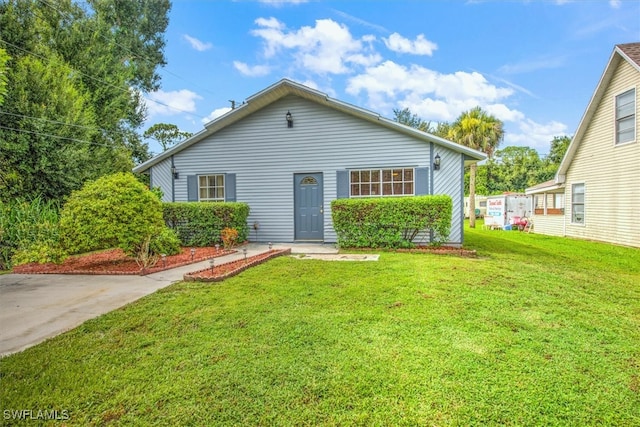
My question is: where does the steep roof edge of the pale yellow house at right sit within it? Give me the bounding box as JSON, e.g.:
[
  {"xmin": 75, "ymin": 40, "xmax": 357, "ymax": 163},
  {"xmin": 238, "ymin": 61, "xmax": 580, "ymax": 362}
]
[{"xmin": 555, "ymin": 43, "xmax": 640, "ymax": 184}]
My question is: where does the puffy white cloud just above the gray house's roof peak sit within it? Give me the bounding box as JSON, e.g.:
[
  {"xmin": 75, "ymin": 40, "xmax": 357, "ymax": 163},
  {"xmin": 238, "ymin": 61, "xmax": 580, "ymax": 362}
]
[{"xmin": 251, "ymin": 18, "xmax": 381, "ymax": 74}]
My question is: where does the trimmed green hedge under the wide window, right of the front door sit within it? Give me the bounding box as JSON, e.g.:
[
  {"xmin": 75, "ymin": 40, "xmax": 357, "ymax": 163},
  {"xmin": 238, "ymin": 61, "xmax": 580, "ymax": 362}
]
[{"xmin": 331, "ymin": 195, "xmax": 453, "ymax": 248}]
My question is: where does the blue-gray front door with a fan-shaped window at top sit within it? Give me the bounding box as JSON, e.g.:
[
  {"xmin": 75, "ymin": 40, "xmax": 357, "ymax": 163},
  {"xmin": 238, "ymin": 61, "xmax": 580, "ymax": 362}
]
[{"xmin": 293, "ymin": 173, "xmax": 324, "ymax": 241}]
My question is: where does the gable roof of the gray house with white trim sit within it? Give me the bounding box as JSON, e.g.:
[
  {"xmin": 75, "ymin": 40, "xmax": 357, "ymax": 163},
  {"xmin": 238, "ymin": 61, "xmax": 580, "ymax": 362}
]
[{"xmin": 133, "ymin": 79, "xmax": 487, "ymax": 173}]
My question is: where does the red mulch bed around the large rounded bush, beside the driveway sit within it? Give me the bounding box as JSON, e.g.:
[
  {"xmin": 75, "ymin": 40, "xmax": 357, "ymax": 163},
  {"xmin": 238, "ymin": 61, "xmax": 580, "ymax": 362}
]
[{"xmin": 13, "ymin": 247, "xmax": 236, "ymax": 276}]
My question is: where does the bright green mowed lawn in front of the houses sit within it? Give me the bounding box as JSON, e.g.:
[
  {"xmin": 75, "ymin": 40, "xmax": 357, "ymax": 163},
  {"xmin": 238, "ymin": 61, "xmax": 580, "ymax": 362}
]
[{"xmin": 0, "ymin": 229, "xmax": 640, "ymax": 426}]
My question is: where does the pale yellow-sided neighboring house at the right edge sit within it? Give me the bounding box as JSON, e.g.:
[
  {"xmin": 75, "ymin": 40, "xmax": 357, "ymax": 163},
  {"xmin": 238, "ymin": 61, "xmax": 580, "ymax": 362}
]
[{"xmin": 526, "ymin": 43, "xmax": 640, "ymax": 247}]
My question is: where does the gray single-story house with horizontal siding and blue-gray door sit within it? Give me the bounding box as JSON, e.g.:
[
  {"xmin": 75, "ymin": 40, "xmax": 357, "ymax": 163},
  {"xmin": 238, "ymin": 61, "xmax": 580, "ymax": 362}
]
[{"xmin": 134, "ymin": 79, "xmax": 485, "ymax": 245}]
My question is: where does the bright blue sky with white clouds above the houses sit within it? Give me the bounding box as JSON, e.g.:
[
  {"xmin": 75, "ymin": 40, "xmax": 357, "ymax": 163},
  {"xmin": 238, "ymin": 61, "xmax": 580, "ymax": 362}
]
[{"xmin": 145, "ymin": 0, "xmax": 640, "ymax": 154}]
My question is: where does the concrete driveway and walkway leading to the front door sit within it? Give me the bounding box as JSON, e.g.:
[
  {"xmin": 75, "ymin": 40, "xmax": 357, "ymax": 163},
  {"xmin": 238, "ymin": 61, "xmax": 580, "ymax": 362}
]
[{"xmin": 0, "ymin": 243, "xmax": 337, "ymax": 356}]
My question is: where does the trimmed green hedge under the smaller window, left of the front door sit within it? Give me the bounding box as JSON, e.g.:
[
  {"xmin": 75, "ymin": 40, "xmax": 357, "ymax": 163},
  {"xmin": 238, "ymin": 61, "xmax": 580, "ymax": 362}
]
[{"xmin": 162, "ymin": 202, "xmax": 249, "ymax": 247}]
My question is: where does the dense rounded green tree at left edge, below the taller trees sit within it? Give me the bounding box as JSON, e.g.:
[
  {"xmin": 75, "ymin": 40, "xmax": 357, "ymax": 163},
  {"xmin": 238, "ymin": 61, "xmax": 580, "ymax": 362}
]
[{"xmin": 0, "ymin": 55, "xmax": 126, "ymax": 200}]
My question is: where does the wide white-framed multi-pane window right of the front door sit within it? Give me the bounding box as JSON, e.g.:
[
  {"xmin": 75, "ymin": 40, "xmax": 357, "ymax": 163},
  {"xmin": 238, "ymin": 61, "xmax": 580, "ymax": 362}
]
[{"xmin": 349, "ymin": 168, "xmax": 414, "ymax": 197}]
